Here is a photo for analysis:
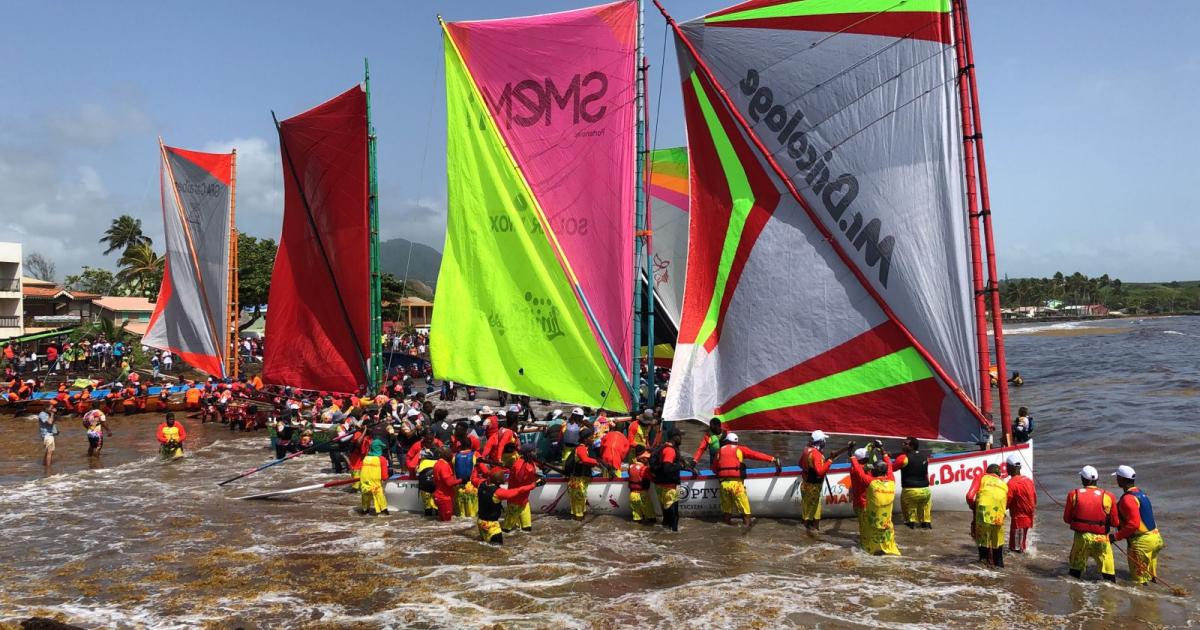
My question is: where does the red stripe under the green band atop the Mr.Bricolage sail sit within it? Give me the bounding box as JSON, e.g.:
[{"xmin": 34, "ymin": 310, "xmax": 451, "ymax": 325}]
[{"xmin": 704, "ymin": 11, "xmax": 952, "ymax": 46}]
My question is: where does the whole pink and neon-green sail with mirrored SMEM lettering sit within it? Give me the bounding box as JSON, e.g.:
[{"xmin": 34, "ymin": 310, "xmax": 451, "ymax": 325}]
[{"xmin": 430, "ymin": 1, "xmax": 637, "ymax": 412}]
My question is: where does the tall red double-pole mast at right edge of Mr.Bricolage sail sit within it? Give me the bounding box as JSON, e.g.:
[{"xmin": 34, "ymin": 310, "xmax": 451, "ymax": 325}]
[{"xmin": 954, "ymin": 0, "xmax": 1013, "ymax": 446}]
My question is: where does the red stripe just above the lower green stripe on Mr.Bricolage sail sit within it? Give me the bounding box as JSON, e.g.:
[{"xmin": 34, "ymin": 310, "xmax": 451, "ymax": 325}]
[{"xmin": 716, "ymin": 320, "xmax": 908, "ymax": 414}]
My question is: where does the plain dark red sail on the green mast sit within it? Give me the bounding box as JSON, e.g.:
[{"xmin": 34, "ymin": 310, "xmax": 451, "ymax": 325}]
[{"xmin": 263, "ymin": 85, "xmax": 371, "ymax": 392}]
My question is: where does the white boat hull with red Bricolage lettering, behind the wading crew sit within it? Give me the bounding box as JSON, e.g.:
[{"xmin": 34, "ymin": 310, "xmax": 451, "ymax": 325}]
[{"xmin": 384, "ymin": 442, "xmax": 1033, "ymax": 518}]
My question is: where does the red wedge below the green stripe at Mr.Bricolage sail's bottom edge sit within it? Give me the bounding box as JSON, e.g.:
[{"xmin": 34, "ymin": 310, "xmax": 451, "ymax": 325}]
[{"xmin": 725, "ymin": 378, "xmax": 946, "ymax": 439}]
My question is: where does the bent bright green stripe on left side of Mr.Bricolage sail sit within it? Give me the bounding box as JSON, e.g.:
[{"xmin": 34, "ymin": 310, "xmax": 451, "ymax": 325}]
[{"xmin": 691, "ymin": 72, "xmax": 755, "ymax": 344}]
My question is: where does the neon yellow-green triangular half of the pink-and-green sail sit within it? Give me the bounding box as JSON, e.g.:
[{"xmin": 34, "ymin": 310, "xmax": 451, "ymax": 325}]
[{"xmin": 430, "ymin": 31, "xmax": 628, "ymax": 410}]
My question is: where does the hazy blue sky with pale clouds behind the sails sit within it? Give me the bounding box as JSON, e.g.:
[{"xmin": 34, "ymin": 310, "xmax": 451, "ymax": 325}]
[{"xmin": 0, "ymin": 0, "xmax": 1200, "ymax": 282}]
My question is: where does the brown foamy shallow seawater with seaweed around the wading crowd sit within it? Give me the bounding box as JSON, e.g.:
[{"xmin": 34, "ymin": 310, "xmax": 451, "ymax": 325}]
[{"xmin": 0, "ymin": 318, "xmax": 1200, "ymax": 628}]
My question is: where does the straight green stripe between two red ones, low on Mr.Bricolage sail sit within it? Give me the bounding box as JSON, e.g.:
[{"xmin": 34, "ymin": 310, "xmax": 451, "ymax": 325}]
[{"xmin": 719, "ymin": 348, "xmax": 934, "ymax": 421}]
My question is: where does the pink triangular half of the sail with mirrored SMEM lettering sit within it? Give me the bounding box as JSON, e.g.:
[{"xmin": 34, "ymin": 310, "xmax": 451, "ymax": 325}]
[{"xmin": 446, "ymin": 1, "xmax": 637, "ymax": 384}]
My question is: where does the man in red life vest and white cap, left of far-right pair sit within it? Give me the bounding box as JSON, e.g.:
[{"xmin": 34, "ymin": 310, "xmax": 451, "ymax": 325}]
[{"xmin": 1062, "ymin": 466, "xmax": 1117, "ymax": 582}]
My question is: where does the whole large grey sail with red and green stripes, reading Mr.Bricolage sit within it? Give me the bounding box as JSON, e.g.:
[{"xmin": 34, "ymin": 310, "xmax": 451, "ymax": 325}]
[{"xmin": 664, "ymin": 0, "xmax": 990, "ymax": 442}]
